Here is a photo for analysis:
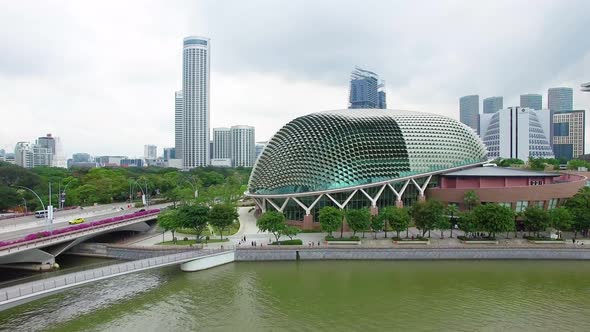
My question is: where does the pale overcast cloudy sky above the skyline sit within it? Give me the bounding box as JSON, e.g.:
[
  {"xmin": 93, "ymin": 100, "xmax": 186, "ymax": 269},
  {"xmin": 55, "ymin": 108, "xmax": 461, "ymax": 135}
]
[{"xmin": 0, "ymin": 0, "xmax": 590, "ymax": 157}]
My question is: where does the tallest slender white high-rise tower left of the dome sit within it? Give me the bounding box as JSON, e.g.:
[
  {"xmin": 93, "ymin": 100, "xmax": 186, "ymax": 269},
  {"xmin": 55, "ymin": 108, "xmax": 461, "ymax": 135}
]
[{"xmin": 181, "ymin": 37, "xmax": 210, "ymax": 169}]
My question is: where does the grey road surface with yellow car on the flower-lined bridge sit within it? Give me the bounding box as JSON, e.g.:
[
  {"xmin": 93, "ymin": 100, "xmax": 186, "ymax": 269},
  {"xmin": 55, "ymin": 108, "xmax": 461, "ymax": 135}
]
[{"xmin": 0, "ymin": 203, "xmax": 170, "ymax": 240}]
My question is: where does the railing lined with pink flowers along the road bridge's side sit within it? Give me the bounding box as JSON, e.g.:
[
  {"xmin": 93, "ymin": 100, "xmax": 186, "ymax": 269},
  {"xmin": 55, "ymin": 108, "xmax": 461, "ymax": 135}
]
[{"xmin": 0, "ymin": 209, "xmax": 160, "ymax": 252}]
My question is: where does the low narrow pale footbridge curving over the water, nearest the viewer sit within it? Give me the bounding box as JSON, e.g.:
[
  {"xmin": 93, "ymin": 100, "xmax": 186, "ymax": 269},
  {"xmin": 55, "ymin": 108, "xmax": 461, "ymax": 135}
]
[{"xmin": 0, "ymin": 249, "xmax": 235, "ymax": 311}]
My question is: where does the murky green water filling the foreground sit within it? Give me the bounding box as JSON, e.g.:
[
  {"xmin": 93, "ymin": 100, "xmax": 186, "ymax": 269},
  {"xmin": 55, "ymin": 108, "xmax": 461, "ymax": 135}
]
[{"xmin": 0, "ymin": 261, "xmax": 590, "ymax": 332}]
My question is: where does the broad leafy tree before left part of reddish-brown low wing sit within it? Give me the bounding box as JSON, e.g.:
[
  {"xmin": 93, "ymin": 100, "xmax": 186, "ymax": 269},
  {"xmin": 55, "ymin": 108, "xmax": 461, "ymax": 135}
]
[{"xmin": 473, "ymin": 204, "xmax": 514, "ymax": 237}]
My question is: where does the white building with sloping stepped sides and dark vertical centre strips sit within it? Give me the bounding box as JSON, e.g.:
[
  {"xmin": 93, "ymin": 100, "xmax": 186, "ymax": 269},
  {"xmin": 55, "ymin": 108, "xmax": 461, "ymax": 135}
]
[{"xmin": 480, "ymin": 107, "xmax": 554, "ymax": 161}]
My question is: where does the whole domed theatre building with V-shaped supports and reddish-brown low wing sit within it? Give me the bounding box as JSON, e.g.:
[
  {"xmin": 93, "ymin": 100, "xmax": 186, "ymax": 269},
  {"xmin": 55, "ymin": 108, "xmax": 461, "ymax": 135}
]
[{"xmin": 247, "ymin": 109, "xmax": 586, "ymax": 229}]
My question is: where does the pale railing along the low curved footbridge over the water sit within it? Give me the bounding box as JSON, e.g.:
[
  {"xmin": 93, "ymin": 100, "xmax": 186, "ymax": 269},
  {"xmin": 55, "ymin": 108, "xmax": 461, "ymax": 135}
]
[{"xmin": 0, "ymin": 249, "xmax": 230, "ymax": 306}]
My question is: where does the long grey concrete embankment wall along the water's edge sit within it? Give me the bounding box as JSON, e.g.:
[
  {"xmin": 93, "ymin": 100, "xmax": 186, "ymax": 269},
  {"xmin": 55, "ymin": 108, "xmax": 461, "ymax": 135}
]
[{"xmin": 235, "ymin": 247, "xmax": 590, "ymax": 262}]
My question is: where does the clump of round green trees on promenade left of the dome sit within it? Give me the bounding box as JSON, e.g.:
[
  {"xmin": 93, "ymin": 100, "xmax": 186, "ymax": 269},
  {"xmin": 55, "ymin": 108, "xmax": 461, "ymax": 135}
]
[{"xmin": 158, "ymin": 204, "xmax": 238, "ymax": 242}]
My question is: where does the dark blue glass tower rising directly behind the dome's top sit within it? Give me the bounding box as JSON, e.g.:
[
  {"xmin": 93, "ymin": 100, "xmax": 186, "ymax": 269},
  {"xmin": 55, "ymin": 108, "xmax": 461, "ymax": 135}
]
[{"xmin": 348, "ymin": 67, "xmax": 387, "ymax": 108}]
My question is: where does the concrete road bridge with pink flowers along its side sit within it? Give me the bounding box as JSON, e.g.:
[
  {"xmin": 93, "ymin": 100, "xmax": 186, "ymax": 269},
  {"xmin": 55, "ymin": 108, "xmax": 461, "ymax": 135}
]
[{"xmin": 0, "ymin": 209, "xmax": 160, "ymax": 270}]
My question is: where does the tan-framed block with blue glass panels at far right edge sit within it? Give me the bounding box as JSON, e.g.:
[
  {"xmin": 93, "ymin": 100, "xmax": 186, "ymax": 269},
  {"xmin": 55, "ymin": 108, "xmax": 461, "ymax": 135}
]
[{"xmin": 552, "ymin": 110, "xmax": 586, "ymax": 160}]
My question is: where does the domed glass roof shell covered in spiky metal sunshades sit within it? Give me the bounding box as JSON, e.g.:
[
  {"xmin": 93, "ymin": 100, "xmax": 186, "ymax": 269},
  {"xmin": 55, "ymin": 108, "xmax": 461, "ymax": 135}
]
[{"xmin": 248, "ymin": 109, "xmax": 486, "ymax": 195}]
